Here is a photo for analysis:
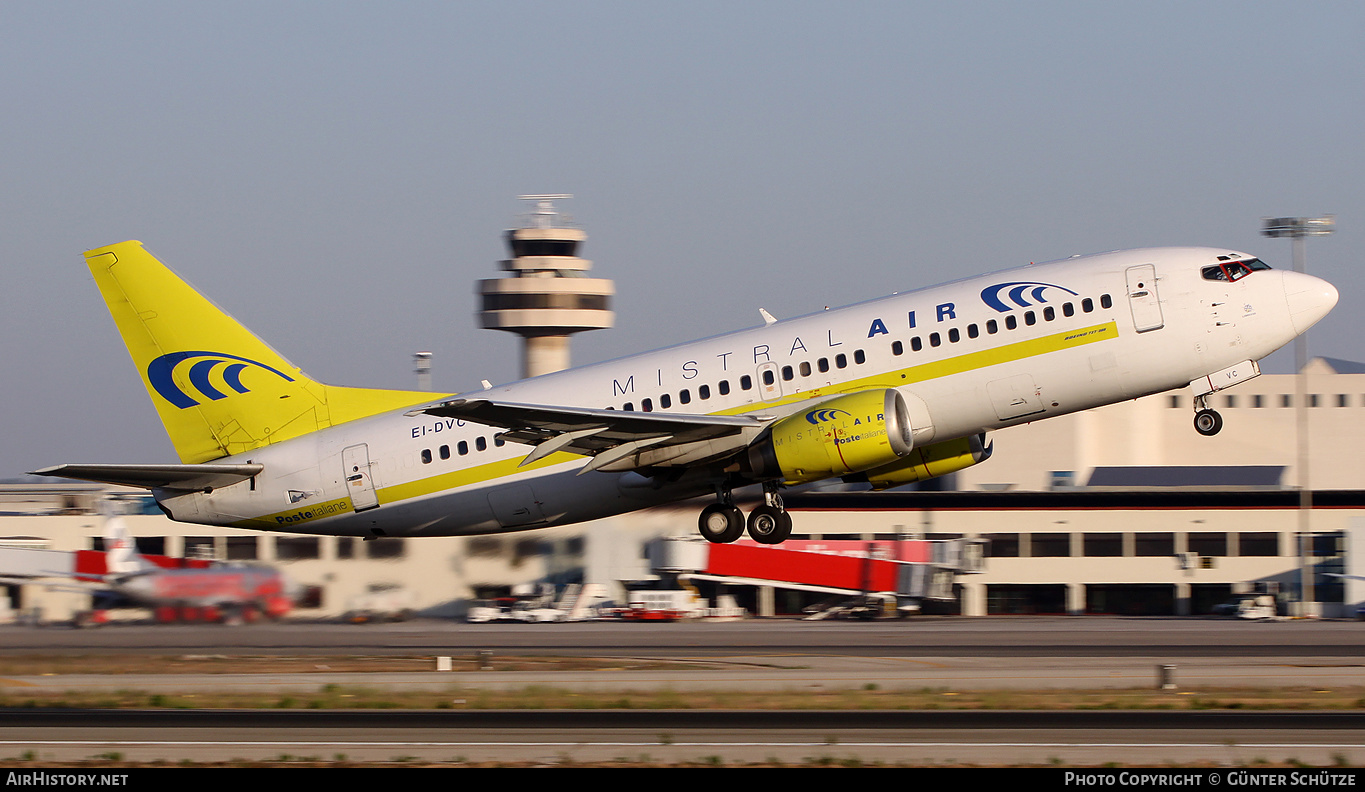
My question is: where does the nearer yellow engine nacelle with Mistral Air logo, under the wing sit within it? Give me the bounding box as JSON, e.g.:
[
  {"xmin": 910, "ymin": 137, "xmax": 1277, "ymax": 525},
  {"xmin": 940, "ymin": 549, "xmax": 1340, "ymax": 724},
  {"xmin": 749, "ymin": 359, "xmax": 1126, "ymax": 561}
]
[{"xmin": 747, "ymin": 388, "xmax": 915, "ymax": 483}]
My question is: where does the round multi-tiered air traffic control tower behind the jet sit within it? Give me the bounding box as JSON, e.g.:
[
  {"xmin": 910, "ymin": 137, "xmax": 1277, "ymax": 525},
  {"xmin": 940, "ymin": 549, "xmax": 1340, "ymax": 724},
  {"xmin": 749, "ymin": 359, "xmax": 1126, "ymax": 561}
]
[{"xmin": 479, "ymin": 195, "xmax": 616, "ymax": 377}]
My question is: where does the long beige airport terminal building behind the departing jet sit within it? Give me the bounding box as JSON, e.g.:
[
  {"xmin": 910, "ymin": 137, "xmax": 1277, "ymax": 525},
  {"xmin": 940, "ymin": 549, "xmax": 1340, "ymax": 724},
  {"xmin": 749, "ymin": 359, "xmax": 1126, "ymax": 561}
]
[{"xmin": 0, "ymin": 358, "xmax": 1365, "ymax": 619}]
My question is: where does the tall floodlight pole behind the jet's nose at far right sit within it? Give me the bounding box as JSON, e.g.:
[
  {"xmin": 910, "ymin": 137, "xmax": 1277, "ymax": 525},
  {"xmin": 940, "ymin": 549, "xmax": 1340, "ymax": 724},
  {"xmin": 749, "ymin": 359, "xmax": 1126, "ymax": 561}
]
[{"xmin": 1261, "ymin": 214, "xmax": 1336, "ymax": 616}]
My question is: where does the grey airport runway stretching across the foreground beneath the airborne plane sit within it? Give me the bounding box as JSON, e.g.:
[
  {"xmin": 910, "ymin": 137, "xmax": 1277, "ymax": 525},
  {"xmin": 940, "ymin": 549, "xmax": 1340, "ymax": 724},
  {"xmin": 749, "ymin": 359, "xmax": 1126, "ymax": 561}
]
[{"xmin": 0, "ymin": 617, "xmax": 1365, "ymax": 766}]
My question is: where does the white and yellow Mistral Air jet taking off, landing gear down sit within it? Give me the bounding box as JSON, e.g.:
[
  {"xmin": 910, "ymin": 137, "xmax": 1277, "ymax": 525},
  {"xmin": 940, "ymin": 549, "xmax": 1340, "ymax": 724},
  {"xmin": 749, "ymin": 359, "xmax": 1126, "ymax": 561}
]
[{"xmin": 34, "ymin": 242, "xmax": 1338, "ymax": 545}]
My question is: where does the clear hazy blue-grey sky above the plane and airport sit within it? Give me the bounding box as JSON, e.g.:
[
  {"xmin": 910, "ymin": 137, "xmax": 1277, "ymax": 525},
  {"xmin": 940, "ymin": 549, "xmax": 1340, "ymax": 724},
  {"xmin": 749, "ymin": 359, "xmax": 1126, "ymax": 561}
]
[{"xmin": 0, "ymin": 1, "xmax": 1365, "ymax": 477}]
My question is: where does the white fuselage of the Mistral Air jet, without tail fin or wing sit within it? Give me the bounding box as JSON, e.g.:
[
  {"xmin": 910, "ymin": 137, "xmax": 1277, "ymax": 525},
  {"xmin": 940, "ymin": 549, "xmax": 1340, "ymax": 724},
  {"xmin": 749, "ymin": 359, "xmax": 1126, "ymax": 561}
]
[{"xmin": 157, "ymin": 249, "xmax": 1336, "ymax": 535}]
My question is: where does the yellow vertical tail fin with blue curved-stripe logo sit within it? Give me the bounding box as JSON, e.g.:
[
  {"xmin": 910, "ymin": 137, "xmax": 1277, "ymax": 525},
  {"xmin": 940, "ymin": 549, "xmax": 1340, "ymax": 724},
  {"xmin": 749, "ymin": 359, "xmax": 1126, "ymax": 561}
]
[{"xmin": 85, "ymin": 242, "xmax": 434, "ymax": 464}]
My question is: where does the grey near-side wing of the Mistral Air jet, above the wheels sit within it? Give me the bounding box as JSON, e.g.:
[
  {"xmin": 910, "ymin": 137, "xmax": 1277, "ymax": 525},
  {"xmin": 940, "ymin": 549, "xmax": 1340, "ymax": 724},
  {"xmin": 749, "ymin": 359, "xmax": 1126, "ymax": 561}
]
[{"xmin": 418, "ymin": 399, "xmax": 775, "ymax": 472}]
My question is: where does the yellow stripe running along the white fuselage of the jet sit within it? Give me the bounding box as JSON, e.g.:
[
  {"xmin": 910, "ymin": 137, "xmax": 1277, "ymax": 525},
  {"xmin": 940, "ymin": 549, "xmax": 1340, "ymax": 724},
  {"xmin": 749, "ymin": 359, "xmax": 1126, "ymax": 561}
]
[{"xmin": 233, "ymin": 315, "xmax": 1118, "ymax": 530}]
